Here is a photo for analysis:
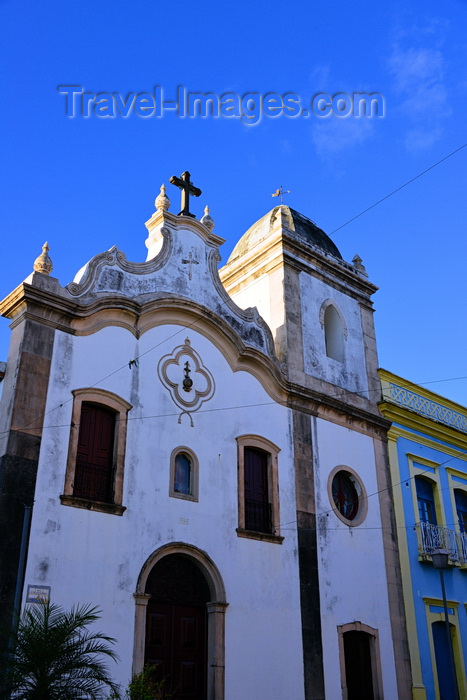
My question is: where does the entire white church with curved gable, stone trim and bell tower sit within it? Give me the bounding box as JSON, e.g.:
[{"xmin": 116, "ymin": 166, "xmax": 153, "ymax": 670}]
[{"xmin": 0, "ymin": 176, "xmax": 411, "ymax": 700}]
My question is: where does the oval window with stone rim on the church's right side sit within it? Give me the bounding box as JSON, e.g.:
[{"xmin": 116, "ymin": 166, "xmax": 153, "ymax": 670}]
[{"xmin": 328, "ymin": 467, "xmax": 367, "ymax": 525}]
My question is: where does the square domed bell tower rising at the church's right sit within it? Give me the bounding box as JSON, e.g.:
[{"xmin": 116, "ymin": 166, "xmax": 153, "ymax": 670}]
[{"xmin": 220, "ymin": 205, "xmax": 379, "ymax": 403}]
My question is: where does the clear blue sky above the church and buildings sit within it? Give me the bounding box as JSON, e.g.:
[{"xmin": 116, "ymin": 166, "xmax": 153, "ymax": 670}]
[{"xmin": 0, "ymin": 0, "xmax": 467, "ymax": 405}]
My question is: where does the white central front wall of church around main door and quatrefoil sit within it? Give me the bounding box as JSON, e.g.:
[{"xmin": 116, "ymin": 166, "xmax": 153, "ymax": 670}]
[{"xmin": 25, "ymin": 325, "xmax": 304, "ymax": 700}]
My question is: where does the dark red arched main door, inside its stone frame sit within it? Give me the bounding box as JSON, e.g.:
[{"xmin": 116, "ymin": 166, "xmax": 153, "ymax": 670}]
[{"xmin": 144, "ymin": 554, "xmax": 210, "ymax": 700}]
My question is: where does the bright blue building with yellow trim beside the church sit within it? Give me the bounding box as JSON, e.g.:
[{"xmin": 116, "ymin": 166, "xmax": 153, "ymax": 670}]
[{"xmin": 380, "ymin": 370, "xmax": 467, "ymax": 700}]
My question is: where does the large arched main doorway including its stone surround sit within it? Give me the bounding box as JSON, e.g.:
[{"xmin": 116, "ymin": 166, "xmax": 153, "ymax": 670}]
[{"xmin": 133, "ymin": 542, "xmax": 228, "ymax": 700}]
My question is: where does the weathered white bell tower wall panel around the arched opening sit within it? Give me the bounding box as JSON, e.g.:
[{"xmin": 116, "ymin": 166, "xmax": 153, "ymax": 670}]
[{"xmin": 300, "ymin": 272, "xmax": 368, "ymax": 393}]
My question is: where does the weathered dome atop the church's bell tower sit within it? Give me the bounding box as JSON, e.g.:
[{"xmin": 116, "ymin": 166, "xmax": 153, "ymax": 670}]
[{"xmin": 228, "ymin": 205, "xmax": 342, "ymax": 262}]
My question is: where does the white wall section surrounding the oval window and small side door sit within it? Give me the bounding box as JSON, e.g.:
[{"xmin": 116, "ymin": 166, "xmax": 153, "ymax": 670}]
[{"xmin": 312, "ymin": 419, "xmax": 397, "ymax": 700}]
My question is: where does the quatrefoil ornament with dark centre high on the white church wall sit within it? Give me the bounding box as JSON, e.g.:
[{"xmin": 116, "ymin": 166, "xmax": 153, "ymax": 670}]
[{"xmin": 157, "ymin": 338, "xmax": 215, "ymax": 427}]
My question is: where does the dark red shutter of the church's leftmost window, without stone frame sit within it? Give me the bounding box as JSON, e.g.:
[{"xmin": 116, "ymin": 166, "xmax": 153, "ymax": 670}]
[{"xmin": 73, "ymin": 403, "xmax": 115, "ymax": 503}]
